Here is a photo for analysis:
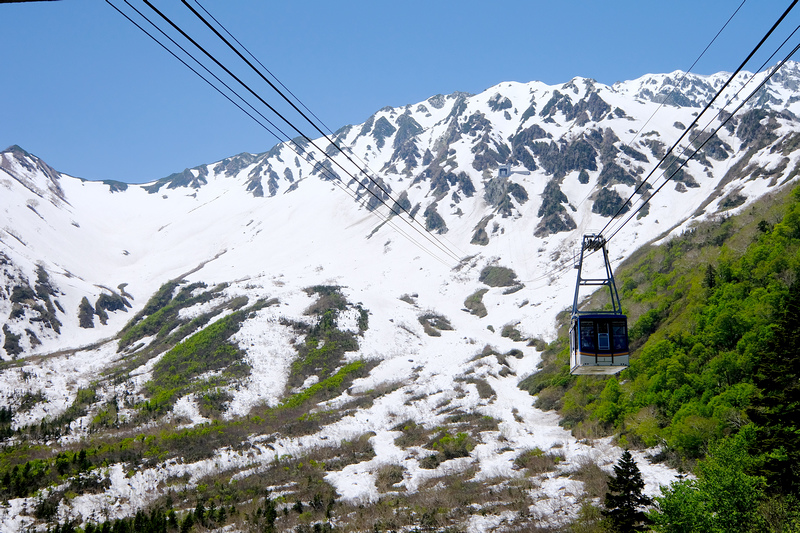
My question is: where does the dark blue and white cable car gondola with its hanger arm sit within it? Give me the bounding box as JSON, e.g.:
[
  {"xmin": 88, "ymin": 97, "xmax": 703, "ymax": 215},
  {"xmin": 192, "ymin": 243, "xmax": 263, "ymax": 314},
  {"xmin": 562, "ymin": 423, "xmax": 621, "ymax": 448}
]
[{"xmin": 569, "ymin": 234, "xmax": 630, "ymax": 375}]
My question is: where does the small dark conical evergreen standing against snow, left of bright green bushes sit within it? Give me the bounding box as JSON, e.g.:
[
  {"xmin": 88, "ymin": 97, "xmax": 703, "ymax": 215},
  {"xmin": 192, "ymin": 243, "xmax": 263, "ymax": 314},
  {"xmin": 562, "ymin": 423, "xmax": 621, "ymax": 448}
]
[{"xmin": 603, "ymin": 450, "xmax": 653, "ymax": 533}]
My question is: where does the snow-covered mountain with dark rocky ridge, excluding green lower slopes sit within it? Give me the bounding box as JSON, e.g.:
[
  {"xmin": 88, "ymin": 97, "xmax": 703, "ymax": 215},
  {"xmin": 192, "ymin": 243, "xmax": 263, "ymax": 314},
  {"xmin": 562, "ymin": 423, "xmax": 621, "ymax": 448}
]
[{"xmin": 0, "ymin": 63, "xmax": 800, "ymax": 531}]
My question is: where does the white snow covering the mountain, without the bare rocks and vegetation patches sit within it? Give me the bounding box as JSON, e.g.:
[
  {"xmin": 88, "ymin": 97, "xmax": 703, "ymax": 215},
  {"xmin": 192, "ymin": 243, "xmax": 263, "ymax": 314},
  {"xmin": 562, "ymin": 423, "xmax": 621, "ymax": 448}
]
[{"xmin": 0, "ymin": 64, "xmax": 800, "ymax": 531}]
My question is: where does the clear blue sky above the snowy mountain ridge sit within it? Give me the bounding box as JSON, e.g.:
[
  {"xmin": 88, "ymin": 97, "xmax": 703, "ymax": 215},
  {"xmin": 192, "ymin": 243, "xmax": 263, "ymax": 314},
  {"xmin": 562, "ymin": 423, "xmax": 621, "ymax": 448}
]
[{"xmin": 0, "ymin": 0, "xmax": 800, "ymax": 182}]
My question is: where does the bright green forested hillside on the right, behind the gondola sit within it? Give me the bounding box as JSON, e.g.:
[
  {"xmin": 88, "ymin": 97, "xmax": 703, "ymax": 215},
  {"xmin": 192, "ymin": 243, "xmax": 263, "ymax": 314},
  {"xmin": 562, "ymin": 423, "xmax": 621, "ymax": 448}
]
[{"xmin": 521, "ymin": 184, "xmax": 800, "ymax": 531}]
